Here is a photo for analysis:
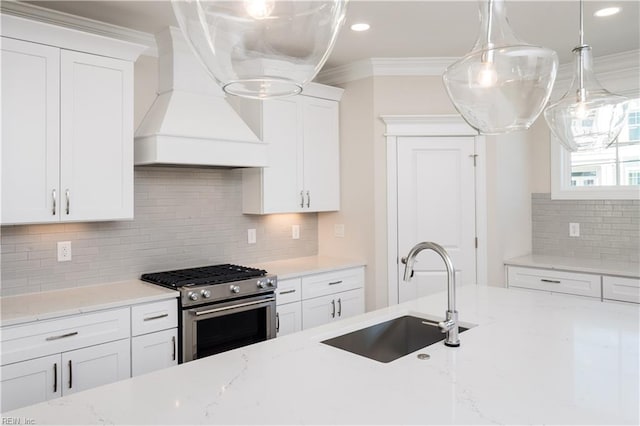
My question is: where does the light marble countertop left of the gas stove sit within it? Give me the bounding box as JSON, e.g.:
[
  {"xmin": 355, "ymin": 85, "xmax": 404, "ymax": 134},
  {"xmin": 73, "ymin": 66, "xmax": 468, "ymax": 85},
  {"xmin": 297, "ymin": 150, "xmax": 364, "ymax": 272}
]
[{"xmin": 0, "ymin": 280, "xmax": 179, "ymax": 327}]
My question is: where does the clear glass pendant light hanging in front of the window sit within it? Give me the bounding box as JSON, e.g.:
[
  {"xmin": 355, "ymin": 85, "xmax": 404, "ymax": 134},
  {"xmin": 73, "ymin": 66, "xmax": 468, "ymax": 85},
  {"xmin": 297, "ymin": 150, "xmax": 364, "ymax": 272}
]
[{"xmin": 544, "ymin": 0, "xmax": 628, "ymax": 151}]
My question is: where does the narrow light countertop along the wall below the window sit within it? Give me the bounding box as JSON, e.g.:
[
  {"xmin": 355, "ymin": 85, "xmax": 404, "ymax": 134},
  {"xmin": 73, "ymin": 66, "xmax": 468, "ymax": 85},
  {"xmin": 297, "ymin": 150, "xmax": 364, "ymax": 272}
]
[{"xmin": 504, "ymin": 254, "xmax": 640, "ymax": 278}]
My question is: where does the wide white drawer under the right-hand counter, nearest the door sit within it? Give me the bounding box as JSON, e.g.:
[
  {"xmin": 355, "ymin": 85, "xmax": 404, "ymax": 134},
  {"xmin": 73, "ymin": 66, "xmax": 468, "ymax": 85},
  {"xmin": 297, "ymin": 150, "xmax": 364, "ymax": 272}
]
[{"xmin": 507, "ymin": 266, "xmax": 602, "ymax": 298}]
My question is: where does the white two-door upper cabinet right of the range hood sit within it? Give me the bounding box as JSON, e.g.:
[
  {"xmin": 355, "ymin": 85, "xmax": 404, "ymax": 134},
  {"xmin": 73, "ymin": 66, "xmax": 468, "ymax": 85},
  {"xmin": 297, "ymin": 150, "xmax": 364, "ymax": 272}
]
[{"xmin": 243, "ymin": 88, "xmax": 341, "ymax": 214}]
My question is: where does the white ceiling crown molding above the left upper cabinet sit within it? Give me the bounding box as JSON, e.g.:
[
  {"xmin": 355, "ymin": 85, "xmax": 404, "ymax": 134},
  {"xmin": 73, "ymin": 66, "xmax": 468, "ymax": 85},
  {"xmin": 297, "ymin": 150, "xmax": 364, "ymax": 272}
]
[{"xmin": 0, "ymin": 0, "xmax": 158, "ymax": 56}]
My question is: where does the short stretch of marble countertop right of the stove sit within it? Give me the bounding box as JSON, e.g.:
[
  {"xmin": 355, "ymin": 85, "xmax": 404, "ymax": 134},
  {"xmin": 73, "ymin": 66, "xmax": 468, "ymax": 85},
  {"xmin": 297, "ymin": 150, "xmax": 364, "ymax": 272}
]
[{"xmin": 250, "ymin": 256, "xmax": 365, "ymax": 280}]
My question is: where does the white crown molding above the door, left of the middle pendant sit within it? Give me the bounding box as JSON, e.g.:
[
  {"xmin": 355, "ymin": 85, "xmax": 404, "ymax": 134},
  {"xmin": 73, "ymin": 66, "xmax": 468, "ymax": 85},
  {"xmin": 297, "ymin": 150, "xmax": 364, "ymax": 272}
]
[{"xmin": 316, "ymin": 57, "xmax": 458, "ymax": 84}]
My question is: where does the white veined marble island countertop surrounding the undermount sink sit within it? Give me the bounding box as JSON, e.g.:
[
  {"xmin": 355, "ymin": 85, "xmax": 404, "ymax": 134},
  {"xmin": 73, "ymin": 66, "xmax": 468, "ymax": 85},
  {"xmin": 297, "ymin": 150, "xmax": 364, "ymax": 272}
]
[{"xmin": 3, "ymin": 286, "xmax": 640, "ymax": 425}]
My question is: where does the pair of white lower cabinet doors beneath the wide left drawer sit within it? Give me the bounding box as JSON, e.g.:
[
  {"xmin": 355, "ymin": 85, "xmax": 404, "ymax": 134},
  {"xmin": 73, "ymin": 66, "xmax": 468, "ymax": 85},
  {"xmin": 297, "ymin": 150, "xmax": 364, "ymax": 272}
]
[{"xmin": 0, "ymin": 339, "xmax": 131, "ymax": 412}]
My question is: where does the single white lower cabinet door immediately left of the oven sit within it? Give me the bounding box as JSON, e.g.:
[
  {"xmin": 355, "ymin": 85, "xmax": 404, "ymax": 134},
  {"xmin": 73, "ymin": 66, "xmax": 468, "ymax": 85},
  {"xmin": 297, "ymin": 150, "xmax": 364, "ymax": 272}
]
[{"xmin": 131, "ymin": 328, "xmax": 178, "ymax": 377}]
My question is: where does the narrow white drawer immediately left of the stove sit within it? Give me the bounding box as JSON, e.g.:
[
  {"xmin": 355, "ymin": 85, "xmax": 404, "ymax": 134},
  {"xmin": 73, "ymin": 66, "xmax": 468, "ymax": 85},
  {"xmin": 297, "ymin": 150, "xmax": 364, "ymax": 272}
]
[{"xmin": 131, "ymin": 299, "xmax": 178, "ymax": 336}]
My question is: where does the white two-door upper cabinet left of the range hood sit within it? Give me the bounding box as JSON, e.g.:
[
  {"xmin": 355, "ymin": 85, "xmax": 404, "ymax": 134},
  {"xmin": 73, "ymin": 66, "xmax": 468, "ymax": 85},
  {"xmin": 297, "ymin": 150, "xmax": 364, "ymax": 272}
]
[{"xmin": 0, "ymin": 15, "xmax": 143, "ymax": 224}]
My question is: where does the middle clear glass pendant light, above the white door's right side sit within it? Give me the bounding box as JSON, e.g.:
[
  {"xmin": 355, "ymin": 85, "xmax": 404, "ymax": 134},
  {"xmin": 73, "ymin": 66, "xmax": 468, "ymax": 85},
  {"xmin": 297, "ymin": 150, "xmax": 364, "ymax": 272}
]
[{"xmin": 442, "ymin": 0, "xmax": 558, "ymax": 134}]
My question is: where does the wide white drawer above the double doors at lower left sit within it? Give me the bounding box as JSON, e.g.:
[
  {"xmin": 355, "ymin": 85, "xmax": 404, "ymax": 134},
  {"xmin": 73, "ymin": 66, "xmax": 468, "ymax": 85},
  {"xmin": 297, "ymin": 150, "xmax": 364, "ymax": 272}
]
[{"xmin": 1, "ymin": 307, "xmax": 131, "ymax": 365}]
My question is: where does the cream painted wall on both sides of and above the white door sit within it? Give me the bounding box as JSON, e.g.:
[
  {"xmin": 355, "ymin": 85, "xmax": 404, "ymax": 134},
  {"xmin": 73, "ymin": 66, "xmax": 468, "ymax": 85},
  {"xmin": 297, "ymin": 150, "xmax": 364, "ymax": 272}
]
[{"xmin": 318, "ymin": 76, "xmax": 536, "ymax": 310}]
